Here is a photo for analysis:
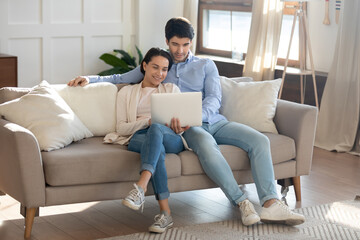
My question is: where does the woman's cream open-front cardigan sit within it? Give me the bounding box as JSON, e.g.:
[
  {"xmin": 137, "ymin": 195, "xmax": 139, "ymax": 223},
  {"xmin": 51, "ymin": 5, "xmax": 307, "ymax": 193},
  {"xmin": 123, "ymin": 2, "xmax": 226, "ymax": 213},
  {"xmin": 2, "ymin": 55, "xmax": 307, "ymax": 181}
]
[{"xmin": 104, "ymin": 83, "xmax": 180, "ymax": 145}]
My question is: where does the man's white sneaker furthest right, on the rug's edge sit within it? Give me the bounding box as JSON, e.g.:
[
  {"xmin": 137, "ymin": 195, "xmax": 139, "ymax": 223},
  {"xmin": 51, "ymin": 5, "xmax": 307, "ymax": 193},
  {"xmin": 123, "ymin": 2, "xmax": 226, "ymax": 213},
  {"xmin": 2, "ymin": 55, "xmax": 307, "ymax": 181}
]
[{"xmin": 260, "ymin": 200, "xmax": 305, "ymax": 226}]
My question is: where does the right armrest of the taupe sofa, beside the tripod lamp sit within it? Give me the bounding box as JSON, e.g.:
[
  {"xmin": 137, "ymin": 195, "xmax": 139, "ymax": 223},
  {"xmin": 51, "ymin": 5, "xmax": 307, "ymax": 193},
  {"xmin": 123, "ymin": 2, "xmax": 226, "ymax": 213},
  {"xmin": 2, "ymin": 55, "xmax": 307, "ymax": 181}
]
[{"xmin": 274, "ymin": 99, "xmax": 318, "ymax": 176}]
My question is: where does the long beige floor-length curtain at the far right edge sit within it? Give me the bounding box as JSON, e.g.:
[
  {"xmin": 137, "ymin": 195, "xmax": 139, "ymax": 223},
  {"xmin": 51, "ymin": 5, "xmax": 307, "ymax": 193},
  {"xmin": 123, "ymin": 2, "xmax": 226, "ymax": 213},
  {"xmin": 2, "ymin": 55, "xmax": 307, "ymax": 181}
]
[{"xmin": 315, "ymin": 0, "xmax": 360, "ymax": 154}]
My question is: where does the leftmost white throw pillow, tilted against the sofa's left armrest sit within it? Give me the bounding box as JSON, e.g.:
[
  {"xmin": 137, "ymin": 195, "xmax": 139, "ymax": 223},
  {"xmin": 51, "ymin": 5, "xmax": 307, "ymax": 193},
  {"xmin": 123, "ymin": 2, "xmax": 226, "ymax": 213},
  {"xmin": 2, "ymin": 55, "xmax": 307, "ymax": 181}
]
[{"xmin": 0, "ymin": 81, "xmax": 93, "ymax": 151}]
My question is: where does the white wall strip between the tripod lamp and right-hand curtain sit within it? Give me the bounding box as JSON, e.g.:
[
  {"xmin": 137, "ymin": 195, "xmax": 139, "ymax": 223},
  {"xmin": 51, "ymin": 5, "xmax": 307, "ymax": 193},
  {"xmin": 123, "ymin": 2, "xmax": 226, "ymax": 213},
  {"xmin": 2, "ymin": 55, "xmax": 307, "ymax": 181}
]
[{"xmin": 308, "ymin": 0, "xmax": 338, "ymax": 72}]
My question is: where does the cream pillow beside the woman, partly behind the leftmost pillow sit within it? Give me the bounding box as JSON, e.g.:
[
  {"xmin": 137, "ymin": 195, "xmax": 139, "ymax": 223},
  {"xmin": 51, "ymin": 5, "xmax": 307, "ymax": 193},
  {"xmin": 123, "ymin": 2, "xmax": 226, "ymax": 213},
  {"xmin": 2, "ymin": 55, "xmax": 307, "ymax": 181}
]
[{"xmin": 51, "ymin": 82, "xmax": 117, "ymax": 136}]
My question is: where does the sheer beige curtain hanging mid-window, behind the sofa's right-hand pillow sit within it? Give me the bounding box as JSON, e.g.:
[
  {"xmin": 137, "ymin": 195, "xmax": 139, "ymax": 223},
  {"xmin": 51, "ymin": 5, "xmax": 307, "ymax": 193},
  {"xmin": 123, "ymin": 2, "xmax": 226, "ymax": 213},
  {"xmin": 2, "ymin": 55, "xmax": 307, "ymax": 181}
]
[{"xmin": 243, "ymin": 0, "xmax": 283, "ymax": 81}]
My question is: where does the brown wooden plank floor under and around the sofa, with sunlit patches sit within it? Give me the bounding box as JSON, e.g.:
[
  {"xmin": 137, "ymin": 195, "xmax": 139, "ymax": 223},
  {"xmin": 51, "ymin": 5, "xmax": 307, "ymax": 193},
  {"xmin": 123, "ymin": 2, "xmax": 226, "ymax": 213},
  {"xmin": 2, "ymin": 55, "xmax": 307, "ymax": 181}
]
[{"xmin": 0, "ymin": 148, "xmax": 360, "ymax": 240}]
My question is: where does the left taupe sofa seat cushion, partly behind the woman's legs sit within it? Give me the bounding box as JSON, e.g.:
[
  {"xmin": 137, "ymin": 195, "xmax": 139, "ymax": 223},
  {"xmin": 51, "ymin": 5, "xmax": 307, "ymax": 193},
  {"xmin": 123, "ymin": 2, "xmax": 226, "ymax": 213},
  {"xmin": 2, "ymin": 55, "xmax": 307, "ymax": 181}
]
[{"xmin": 41, "ymin": 137, "xmax": 181, "ymax": 186}]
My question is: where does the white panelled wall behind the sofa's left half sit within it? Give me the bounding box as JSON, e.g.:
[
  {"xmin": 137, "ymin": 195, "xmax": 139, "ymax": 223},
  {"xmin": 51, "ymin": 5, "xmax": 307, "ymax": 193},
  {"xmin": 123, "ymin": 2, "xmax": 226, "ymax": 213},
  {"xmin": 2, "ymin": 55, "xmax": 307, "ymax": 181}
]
[{"xmin": 0, "ymin": 0, "xmax": 138, "ymax": 87}]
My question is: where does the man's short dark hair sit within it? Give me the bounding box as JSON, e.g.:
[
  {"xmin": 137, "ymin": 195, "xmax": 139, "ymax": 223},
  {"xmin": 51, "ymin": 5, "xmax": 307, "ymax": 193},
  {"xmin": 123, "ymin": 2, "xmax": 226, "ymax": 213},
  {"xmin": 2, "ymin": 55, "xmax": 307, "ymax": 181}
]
[{"xmin": 165, "ymin": 17, "xmax": 195, "ymax": 41}]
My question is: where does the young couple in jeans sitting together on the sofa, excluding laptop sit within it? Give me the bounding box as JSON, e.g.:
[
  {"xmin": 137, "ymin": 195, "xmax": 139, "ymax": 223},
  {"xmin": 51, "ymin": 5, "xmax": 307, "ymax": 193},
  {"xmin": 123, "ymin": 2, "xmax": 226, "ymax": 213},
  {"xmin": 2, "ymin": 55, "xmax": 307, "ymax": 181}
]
[{"xmin": 68, "ymin": 18, "xmax": 305, "ymax": 233}]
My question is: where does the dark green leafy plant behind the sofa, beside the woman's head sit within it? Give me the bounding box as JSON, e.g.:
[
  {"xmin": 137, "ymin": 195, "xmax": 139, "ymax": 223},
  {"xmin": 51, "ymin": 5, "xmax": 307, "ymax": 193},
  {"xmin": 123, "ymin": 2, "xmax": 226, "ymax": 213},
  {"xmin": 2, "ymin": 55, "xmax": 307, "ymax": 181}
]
[{"xmin": 98, "ymin": 46, "xmax": 143, "ymax": 76}]
